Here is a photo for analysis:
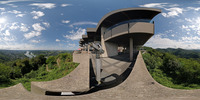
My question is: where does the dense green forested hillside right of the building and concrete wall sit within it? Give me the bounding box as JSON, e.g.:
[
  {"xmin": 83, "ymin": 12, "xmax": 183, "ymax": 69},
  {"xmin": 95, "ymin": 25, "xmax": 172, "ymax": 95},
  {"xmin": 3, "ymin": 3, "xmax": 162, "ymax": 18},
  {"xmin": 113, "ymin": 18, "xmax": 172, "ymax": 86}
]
[{"xmin": 142, "ymin": 47, "xmax": 200, "ymax": 89}]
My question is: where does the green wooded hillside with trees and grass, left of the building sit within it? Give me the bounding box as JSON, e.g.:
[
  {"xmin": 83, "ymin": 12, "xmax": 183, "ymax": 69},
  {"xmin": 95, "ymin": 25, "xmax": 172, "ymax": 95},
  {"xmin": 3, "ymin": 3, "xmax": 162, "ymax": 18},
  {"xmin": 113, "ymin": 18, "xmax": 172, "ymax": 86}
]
[{"xmin": 0, "ymin": 50, "xmax": 78, "ymax": 90}]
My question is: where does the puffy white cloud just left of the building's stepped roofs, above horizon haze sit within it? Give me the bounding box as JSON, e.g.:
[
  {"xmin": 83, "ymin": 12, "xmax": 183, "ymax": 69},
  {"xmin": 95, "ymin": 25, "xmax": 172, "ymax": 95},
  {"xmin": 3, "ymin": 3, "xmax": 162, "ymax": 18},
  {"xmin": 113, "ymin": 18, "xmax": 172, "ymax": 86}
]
[{"xmin": 64, "ymin": 28, "xmax": 86, "ymax": 40}]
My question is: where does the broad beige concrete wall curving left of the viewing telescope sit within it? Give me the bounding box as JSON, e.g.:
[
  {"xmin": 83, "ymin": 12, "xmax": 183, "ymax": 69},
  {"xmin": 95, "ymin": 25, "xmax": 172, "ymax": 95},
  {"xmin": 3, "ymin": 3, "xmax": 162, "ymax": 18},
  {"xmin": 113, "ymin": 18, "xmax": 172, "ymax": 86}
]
[{"xmin": 31, "ymin": 53, "xmax": 90, "ymax": 95}]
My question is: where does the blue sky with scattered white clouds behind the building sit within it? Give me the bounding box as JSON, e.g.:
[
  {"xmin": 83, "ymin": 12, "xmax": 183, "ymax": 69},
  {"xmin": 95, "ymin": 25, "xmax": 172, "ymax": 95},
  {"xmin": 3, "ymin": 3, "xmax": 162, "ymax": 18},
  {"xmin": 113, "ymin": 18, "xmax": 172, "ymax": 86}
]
[{"xmin": 0, "ymin": 0, "xmax": 200, "ymax": 50}]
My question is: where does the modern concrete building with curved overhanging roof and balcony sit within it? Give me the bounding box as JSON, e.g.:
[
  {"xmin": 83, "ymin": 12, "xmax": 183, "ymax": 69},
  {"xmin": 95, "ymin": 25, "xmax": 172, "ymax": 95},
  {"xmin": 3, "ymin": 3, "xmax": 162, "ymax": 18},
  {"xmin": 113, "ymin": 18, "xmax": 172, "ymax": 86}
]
[{"xmin": 79, "ymin": 8, "xmax": 161, "ymax": 61}]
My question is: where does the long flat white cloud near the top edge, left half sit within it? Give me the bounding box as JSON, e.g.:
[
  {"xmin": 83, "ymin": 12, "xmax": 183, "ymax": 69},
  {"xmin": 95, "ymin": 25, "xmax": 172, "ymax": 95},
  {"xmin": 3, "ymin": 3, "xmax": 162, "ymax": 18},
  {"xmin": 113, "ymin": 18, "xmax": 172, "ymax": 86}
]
[{"xmin": 30, "ymin": 3, "xmax": 56, "ymax": 9}]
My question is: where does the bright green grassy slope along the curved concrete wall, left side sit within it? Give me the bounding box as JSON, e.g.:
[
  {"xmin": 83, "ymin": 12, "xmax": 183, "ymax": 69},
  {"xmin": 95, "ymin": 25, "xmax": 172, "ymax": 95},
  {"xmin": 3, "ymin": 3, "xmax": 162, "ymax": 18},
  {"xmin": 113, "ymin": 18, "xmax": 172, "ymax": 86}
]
[{"xmin": 14, "ymin": 62, "xmax": 78, "ymax": 91}]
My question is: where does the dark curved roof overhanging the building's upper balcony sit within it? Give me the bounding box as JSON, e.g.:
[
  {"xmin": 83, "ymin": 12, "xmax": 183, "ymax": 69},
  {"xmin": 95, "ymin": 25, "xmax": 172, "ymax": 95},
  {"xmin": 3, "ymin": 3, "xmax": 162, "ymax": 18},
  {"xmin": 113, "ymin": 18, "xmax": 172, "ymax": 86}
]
[{"xmin": 96, "ymin": 8, "xmax": 161, "ymax": 34}]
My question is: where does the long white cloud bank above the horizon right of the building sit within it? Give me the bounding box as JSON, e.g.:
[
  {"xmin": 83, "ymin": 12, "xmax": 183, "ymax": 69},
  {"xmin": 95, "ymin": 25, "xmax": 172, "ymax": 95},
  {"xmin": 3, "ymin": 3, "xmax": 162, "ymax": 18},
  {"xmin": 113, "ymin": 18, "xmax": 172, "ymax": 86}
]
[{"xmin": 145, "ymin": 35, "xmax": 200, "ymax": 49}]
